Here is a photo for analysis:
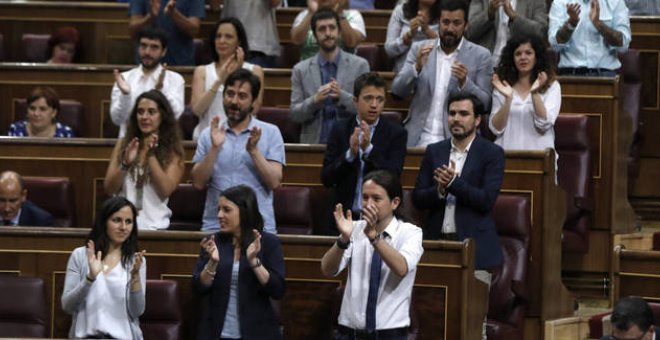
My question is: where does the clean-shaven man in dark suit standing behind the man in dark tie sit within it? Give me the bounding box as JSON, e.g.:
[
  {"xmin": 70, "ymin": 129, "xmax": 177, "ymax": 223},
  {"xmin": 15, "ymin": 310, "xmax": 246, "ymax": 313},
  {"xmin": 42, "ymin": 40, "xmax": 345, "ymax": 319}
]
[{"xmin": 321, "ymin": 72, "xmax": 407, "ymax": 235}]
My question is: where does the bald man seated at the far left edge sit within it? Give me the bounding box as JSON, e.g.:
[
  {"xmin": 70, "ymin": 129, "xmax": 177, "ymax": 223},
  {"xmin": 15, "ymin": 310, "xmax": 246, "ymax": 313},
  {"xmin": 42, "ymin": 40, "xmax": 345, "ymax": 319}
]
[{"xmin": 0, "ymin": 171, "xmax": 53, "ymax": 227}]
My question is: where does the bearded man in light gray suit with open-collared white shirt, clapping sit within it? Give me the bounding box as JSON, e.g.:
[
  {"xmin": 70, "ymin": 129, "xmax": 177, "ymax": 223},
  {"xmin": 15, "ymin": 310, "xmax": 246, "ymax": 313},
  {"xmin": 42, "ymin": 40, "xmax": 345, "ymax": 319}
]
[{"xmin": 392, "ymin": 0, "xmax": 493, "ymax": 146}]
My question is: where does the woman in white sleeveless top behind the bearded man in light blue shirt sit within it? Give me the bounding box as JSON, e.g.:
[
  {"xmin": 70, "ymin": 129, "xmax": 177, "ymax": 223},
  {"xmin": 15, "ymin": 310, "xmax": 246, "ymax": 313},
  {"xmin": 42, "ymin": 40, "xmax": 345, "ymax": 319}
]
[{"xmin": 190, "ymin": 17, "xmax": 264, "ymax": 140}]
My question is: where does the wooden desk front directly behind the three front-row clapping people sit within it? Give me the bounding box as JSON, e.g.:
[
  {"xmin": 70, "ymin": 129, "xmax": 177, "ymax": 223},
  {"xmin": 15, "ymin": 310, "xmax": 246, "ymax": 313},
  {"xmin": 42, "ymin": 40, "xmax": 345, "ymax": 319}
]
[{"xmin": 0, "ymin": 227, "xmax": 488, "ymax": 339}]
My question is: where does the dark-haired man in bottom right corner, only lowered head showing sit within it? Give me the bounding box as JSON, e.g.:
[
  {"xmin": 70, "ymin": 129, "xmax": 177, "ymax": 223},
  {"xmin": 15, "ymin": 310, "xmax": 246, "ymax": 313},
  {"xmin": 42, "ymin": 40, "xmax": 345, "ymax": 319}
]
[{"xmin": 601, "ymin": 296, "xmax": 660, "ymax": 340}]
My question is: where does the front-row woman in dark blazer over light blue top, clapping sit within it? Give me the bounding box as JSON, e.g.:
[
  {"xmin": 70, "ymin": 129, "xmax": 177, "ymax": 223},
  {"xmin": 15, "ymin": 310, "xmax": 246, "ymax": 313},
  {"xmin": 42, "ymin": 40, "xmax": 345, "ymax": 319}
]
[{"xmin": 192, "ymin": 185, "xmax": 285, "ymax": 340}]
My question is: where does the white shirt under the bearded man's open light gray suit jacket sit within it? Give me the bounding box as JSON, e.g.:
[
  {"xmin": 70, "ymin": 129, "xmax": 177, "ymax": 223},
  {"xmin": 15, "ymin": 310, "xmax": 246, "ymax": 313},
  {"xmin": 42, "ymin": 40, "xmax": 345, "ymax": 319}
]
[{"xmin": 417, "ymin": 39, "xmax": 463, "ymax": 147}]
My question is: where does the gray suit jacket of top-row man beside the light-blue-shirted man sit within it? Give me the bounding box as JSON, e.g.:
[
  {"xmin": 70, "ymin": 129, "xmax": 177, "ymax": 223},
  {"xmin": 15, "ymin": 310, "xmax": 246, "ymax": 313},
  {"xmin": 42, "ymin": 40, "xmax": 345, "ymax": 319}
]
[{"xmin": 465, "ymin": 0, "xmax": 548, "ymax": 52}]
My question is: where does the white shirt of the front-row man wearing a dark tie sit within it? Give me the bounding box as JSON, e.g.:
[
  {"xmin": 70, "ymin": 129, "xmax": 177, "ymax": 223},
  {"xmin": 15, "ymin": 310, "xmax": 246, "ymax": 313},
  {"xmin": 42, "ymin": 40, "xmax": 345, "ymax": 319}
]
[{"xmin": 336, "ymin": 217, "xmax": 424, "ymax": 330}]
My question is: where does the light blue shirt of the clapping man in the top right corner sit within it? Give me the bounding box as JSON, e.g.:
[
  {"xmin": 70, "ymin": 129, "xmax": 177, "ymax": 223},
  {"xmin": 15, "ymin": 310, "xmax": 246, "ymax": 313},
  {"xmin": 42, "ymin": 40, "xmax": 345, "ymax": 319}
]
[{"xmin": 548, "ymin": 0, "xmax": 631, "ymax": 70}]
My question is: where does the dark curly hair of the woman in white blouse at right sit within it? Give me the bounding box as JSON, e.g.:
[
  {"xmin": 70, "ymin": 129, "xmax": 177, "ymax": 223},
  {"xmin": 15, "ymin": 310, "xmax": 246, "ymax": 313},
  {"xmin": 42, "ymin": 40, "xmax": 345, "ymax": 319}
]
[{"xmin": 497, "ymin": 34, "xmax": 556, "ymax": 93}]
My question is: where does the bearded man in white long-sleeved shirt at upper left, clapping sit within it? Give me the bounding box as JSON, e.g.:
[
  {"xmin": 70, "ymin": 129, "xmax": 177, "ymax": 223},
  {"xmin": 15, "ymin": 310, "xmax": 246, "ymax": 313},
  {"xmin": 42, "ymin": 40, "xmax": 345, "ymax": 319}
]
[{"xmin": 110, "ymin": 28, "xmax": 185, "ymax": 138}]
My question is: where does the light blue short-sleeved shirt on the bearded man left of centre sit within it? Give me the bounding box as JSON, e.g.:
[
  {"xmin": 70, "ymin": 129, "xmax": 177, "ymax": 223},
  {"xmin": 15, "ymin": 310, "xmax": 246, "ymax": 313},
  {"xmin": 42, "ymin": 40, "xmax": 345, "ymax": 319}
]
[{"xmin": 193, "ymin": 117, "xmax": 285, "ymax": 234}]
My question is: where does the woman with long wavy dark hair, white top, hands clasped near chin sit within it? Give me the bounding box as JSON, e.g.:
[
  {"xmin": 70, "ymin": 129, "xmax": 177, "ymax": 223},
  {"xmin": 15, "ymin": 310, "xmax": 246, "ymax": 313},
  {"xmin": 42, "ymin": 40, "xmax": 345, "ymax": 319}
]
[{"xmin": 103, "ymin": 90, "xmax": 184, "ymax": 230}]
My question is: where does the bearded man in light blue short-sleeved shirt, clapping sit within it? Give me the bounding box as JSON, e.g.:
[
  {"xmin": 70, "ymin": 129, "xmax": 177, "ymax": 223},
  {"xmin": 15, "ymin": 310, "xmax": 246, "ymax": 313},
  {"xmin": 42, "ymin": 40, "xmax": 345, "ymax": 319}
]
[{"xmin": 191, "ymin": 69, "xmax": 285, "ymax": 233}]
